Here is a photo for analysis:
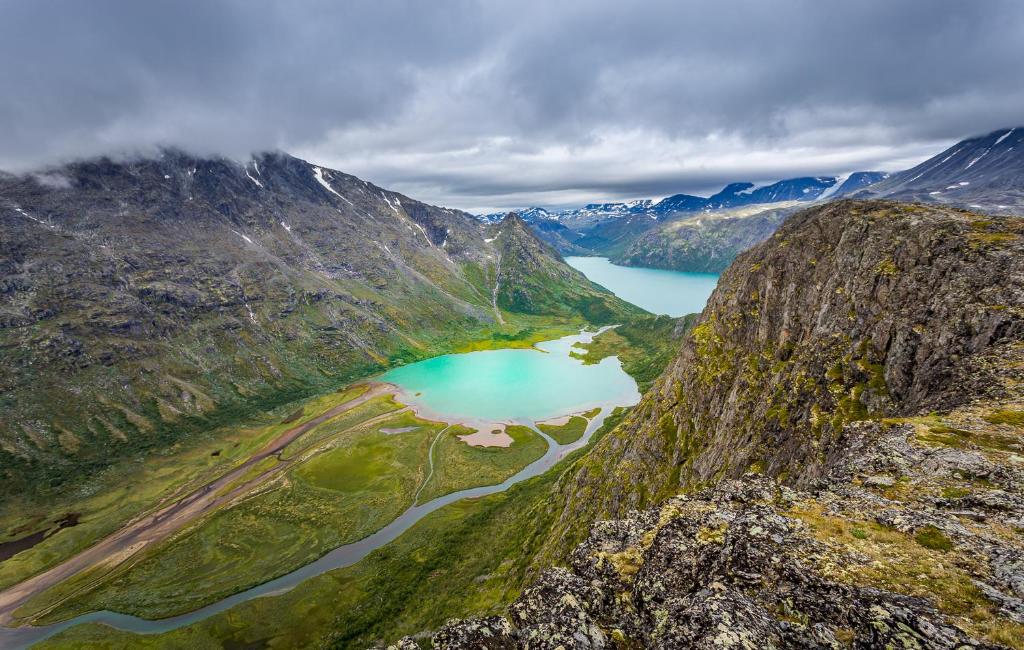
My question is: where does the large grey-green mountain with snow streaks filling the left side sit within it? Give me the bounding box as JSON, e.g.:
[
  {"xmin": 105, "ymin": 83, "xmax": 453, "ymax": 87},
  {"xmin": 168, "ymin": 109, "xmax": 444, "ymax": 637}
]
[{"xmin": 0, "ymin": 151, "xmax": 622, "ymax": 492}]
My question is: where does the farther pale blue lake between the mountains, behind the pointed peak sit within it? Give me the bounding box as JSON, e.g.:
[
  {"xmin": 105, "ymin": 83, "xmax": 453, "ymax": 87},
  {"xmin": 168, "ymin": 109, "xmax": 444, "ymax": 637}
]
[{"xmin": 565, "ymin": 257, "xmax": 718, "ymax": 316}]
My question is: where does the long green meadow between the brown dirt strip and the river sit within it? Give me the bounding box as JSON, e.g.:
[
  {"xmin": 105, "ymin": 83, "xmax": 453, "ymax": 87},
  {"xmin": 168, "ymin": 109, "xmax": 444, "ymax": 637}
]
[{"xmin": 19, "ymin": 409, "xmax": 444, "ymax": 620}]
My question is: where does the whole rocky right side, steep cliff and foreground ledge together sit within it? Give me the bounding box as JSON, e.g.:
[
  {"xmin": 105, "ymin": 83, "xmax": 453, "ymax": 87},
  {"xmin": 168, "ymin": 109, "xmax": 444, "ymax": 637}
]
[{"xmin": 403, "ymin": 201, "xmax": 1024, "ymax": 648}]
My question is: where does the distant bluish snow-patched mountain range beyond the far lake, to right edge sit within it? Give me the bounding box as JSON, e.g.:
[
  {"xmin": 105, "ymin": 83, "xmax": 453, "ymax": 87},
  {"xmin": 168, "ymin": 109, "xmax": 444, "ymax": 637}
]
[{"xmin": 491, "ymin": 128, "xmax": 1024, "ymax": 272}]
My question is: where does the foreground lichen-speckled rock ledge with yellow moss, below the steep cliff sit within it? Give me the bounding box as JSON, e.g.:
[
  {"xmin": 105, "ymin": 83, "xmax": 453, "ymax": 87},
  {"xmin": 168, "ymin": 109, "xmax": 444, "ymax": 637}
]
[{"xmin": 423, "ymin": 401, "xmax": 1024, "ymax": 649}]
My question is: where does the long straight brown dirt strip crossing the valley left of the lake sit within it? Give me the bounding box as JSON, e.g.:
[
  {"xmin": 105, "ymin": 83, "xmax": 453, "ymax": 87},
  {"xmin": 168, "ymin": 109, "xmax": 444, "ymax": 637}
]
[{"xmin": 0, "ymin": 384, "xmax": 394, "ymax": 625}]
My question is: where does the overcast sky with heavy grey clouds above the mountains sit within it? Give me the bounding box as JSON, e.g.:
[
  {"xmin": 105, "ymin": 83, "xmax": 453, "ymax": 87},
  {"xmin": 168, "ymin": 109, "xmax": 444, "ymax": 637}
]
[{"xmin": 0, "ymin": 0, "xmax": 1024, "ymax": 212}]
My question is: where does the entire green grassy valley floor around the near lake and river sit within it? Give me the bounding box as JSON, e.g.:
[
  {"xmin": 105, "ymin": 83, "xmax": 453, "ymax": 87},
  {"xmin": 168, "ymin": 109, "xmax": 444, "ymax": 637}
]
[{"xmin": 0, "ymin": 317, "xmax": 674, "ymax": 647}]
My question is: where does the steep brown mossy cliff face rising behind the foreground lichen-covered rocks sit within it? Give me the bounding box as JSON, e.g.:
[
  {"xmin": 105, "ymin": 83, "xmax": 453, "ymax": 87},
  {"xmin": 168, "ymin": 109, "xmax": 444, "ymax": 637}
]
[{"xmin": 556, "ymin": 201, "xmax": 1024, "ymax": 535}]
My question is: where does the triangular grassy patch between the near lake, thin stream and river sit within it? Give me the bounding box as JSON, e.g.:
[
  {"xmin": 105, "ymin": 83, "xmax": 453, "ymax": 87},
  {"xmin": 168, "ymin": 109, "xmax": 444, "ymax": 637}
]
[{"xmin": 419, "ymin": 425, "xmax": 548, "ymax": 504}]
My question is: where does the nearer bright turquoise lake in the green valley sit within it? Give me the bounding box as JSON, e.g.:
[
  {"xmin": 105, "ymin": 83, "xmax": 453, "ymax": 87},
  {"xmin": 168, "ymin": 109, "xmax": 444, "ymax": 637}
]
[{"xmin": 379, "ymin": 333, "xmax": 640, "ymax": 424}]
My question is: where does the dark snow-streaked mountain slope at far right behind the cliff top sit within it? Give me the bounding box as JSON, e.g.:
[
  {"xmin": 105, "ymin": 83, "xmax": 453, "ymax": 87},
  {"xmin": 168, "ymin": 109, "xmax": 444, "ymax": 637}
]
[{"xmin": 858, "ymin": 127, "xmax": 1024, "ymax": 214}]
